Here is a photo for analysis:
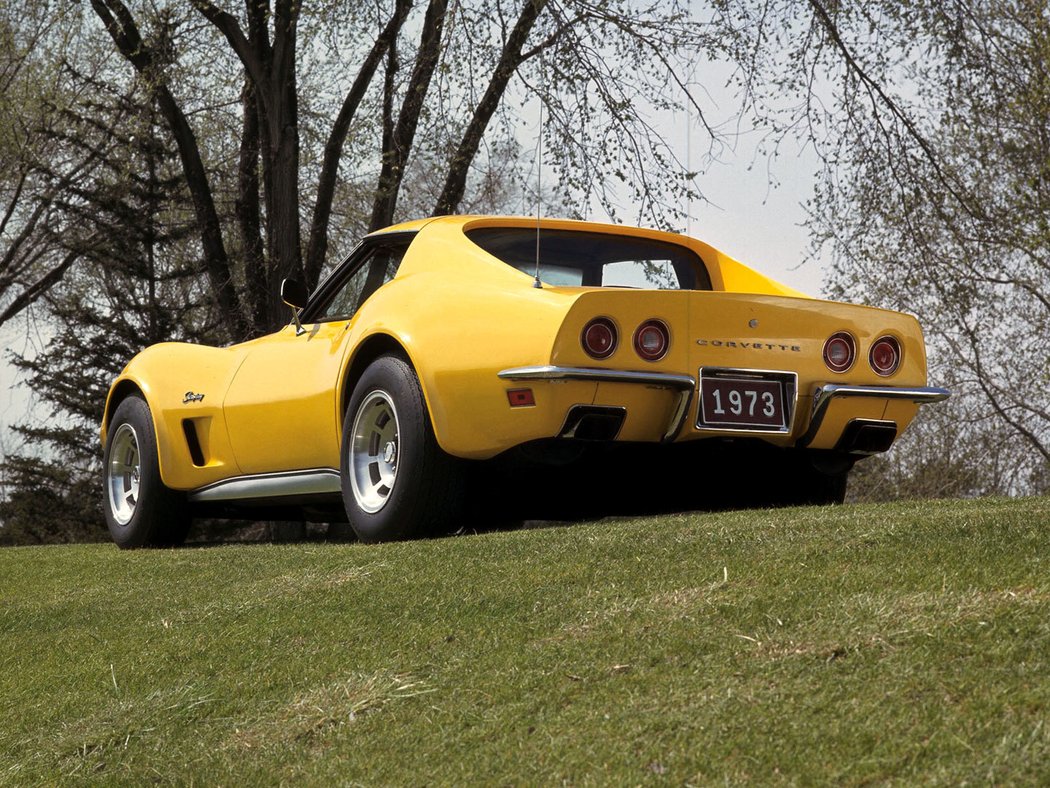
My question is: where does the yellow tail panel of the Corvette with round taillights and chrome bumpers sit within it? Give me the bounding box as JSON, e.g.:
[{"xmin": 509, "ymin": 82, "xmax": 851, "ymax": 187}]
[{"xmin": 499, "ymin": 283, "xmax": 947, "ymax": 456}]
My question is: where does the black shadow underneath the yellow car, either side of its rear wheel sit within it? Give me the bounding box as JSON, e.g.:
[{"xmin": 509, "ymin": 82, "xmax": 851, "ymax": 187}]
[{"xmin": 188, "ymin": 441, "xmax": 831, "ymax": 546}]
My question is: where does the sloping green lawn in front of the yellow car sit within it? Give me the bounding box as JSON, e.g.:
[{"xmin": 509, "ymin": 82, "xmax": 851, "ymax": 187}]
[{"xmin": 0, "ymin": 498, "xmax": 1050, "ymax": 785}]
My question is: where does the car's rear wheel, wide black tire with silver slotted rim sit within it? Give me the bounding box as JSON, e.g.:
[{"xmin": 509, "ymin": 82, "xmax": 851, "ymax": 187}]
[{"xmin": 341, "ymin": 356, "xmax": 463, "ymax": 542}]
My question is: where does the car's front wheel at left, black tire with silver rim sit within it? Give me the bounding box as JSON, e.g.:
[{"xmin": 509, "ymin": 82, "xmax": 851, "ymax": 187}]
[{"xmin": 103, "ymin": 395, "xmax": 190, "ymax": 549}]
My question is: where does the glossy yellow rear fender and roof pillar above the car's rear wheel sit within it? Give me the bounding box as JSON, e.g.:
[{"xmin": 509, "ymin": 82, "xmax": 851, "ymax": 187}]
[{"xmin": 361, "ymin": 223, "xmax": 576, "ymax": 458}]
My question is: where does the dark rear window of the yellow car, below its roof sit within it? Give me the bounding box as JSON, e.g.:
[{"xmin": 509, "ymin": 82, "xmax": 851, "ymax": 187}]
[{"xmin": 466, "ymin": 227, "xmax": 711, "ymax": 290}]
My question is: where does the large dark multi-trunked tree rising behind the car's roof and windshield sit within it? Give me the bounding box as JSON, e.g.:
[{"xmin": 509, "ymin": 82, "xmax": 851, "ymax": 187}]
[{"xmin": 84, "ymin": 0, "xmax": 713, "ymax": 337}]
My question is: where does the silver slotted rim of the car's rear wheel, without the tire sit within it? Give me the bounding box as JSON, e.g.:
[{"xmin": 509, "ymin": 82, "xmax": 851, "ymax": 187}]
[{"xmin": 347, "ymin": 390, "xmax": 400, "ymax": 514}]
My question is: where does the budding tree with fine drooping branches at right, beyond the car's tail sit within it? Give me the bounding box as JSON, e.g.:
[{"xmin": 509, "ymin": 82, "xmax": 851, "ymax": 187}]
[{"xmin": 717, "ymin": 0, "xmax": 1050, "ymax": 492}]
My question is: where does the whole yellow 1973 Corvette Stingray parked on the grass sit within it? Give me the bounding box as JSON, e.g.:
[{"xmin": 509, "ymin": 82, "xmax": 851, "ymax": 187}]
[{"xmin": 102, "ymin": 216, "xmax": 948, "ymax": 547}]
